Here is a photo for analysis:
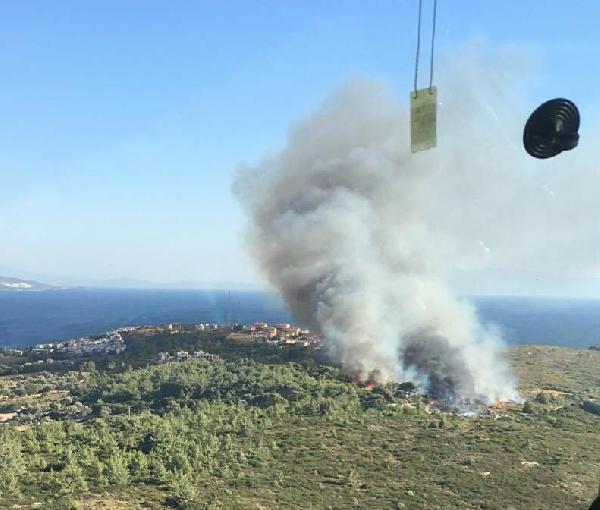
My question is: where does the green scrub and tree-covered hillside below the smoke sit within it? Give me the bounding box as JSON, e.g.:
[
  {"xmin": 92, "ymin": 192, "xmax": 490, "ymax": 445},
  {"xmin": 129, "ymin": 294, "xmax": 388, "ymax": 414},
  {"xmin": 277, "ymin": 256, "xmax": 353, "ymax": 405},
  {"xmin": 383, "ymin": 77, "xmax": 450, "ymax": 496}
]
[{"xmin": 0, "ymin": 335, "xmax": 600, "ymax": 510}]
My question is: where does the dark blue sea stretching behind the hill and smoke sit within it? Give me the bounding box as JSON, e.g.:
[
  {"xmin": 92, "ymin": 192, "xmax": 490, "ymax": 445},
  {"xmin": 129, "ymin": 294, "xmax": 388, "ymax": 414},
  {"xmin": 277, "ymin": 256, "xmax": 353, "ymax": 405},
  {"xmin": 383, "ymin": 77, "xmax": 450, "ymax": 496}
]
[{"xmin": 0, "ymin": 289, "xmax": 600, "ymax": 348}]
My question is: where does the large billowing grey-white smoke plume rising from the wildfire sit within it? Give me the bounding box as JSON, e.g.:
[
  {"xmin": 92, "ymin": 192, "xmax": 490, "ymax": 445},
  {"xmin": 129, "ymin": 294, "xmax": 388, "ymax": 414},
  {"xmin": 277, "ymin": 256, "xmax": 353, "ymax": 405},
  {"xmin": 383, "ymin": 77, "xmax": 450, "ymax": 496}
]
[{"xmin": 234, "ymin": 45, "xmax": 540, "ymax": 402}]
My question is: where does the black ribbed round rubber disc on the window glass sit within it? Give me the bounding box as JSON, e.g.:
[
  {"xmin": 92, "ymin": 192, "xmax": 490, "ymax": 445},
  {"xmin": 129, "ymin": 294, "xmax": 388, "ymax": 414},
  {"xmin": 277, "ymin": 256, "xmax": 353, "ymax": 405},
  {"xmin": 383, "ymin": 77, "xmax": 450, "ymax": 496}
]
[{"xmin": 523, "ymin": 98, "xmax": 579, "ymax": 159}]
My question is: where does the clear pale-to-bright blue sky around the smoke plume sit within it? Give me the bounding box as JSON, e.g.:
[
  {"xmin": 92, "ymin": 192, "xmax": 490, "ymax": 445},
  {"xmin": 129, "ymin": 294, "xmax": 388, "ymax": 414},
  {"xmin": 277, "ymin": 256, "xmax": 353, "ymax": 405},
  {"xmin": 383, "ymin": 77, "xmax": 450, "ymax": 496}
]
[{"xmin": 0, "ymin": 0, "xmax": 600, "ymax": 286}]
